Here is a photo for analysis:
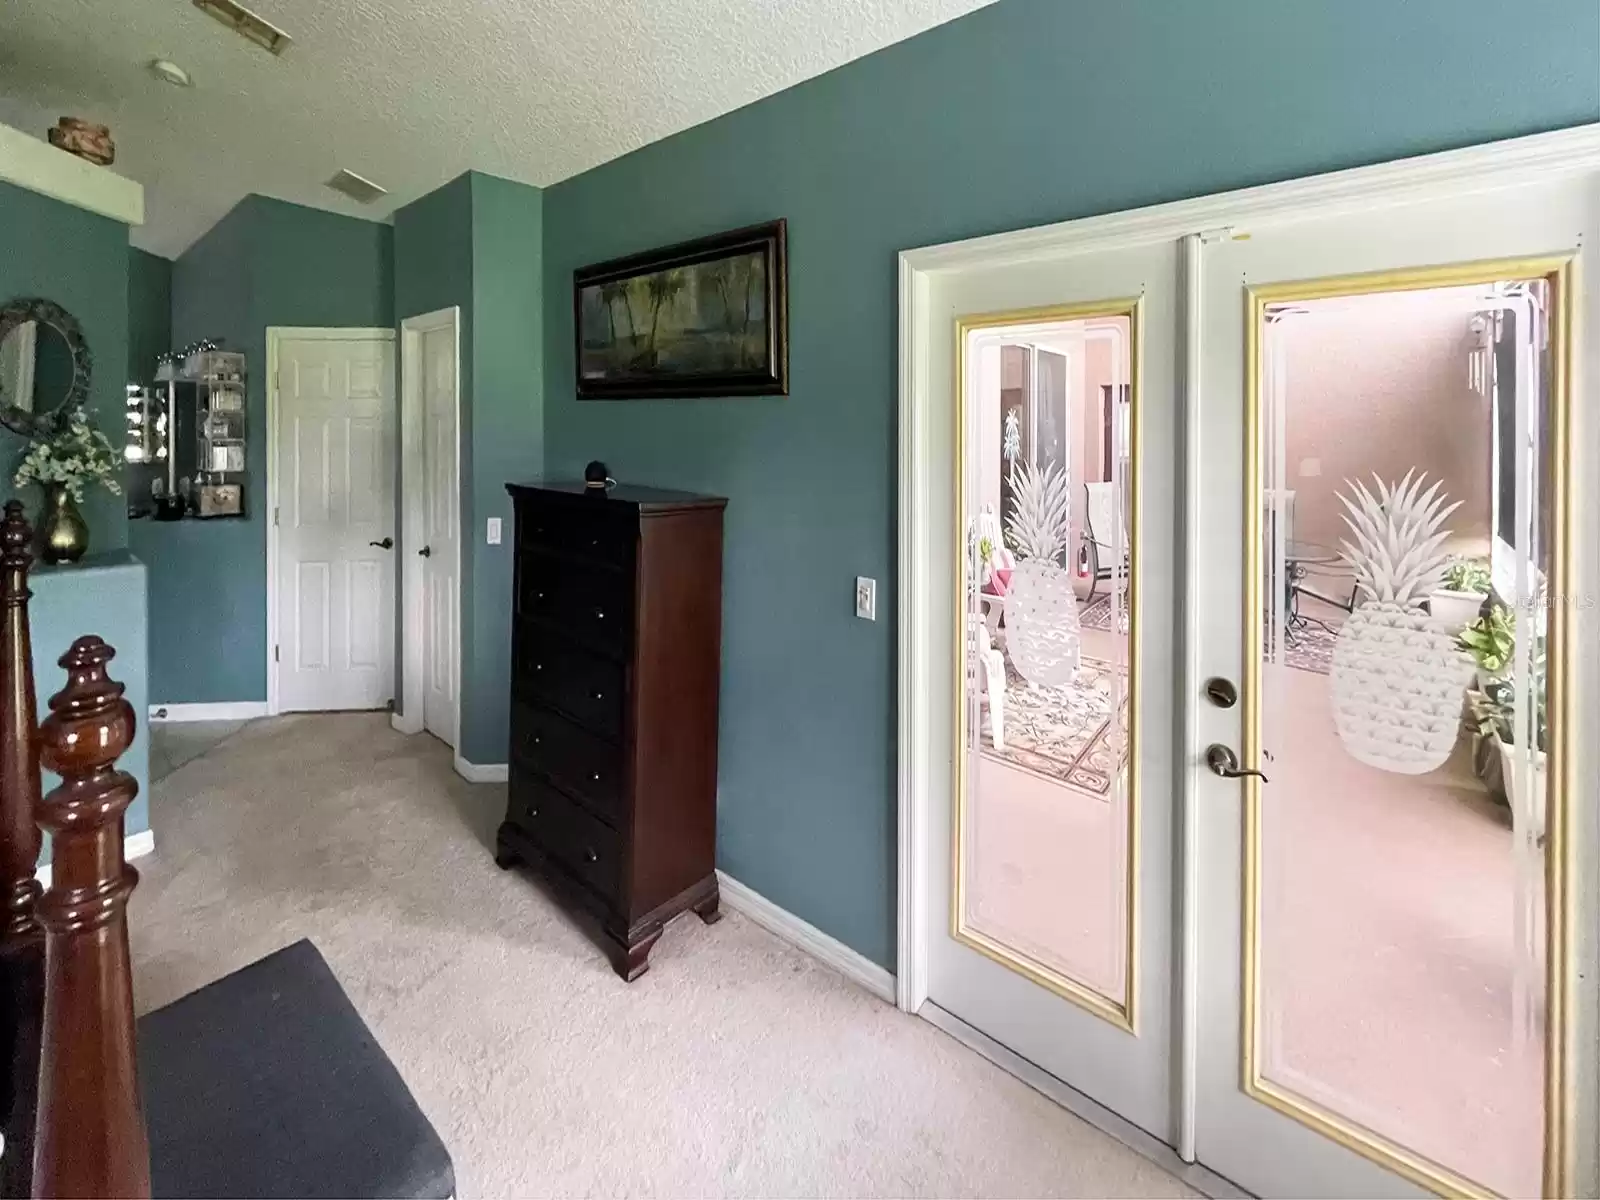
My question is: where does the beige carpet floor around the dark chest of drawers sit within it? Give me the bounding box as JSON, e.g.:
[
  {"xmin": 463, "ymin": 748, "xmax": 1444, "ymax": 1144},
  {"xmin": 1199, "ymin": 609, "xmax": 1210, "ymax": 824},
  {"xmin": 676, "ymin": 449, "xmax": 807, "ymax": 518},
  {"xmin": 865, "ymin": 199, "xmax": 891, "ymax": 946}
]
[{"xmin": 131, "ymin": 715, "xmax": 1192, "ymax": 1197}]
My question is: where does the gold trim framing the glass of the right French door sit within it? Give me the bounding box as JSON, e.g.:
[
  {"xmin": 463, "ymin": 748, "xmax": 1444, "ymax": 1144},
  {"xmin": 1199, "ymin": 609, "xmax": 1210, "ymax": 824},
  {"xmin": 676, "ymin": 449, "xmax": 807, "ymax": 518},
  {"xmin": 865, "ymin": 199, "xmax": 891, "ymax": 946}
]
[{"xmin": 1240, "ymin": 254, "xmax": 1574, "ymax": 1197}]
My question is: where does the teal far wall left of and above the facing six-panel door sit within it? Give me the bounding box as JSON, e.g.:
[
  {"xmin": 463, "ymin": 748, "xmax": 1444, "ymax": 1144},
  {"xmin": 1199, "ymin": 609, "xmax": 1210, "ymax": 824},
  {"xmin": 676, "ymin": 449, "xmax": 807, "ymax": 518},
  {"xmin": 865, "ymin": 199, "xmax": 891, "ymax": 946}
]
[{"xmin": 133, "ymin": 195, "xmax": 394, "ymax": 704}]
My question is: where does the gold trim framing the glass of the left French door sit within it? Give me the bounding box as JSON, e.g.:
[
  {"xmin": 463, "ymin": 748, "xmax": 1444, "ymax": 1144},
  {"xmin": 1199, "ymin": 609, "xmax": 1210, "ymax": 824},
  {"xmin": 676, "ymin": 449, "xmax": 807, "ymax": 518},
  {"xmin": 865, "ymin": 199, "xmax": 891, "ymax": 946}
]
[{"xmin": 950, "ymin": 296, "xmax": 1144, "ymax": 1035}]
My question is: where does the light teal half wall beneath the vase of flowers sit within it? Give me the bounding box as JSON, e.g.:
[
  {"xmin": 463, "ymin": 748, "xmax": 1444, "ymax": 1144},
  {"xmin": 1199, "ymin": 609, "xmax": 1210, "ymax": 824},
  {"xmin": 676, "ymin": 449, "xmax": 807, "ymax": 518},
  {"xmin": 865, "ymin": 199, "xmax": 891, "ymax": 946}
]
[{"xmin": 29, "ymin": 550, "xmax": 150, "ymax": 861}]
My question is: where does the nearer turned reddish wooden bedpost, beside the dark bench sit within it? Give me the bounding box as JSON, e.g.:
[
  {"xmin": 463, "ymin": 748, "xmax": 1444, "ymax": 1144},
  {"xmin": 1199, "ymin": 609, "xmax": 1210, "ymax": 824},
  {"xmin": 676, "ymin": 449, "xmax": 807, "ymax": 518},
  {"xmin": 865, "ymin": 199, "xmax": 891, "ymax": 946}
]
[{"xmin": 34, "ymin": 637, "xmax": 150, "ymax": 1197}]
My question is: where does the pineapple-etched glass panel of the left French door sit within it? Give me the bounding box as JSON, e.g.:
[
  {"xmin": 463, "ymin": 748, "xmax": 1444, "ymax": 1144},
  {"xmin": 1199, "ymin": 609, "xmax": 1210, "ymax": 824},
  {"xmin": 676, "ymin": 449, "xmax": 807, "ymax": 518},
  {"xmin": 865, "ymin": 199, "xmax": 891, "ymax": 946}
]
[{"xmin": 954, "ymin": 312, "xmax": 1138, "ymax": 1026}]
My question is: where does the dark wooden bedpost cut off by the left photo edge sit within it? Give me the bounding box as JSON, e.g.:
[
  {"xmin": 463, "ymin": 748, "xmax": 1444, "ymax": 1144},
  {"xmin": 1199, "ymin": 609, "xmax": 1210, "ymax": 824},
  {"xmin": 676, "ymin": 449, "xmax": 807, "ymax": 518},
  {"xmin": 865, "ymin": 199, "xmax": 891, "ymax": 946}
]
[{"xmin": 0, "ymin": 501, "xmax": 45, "ymax": 1195}]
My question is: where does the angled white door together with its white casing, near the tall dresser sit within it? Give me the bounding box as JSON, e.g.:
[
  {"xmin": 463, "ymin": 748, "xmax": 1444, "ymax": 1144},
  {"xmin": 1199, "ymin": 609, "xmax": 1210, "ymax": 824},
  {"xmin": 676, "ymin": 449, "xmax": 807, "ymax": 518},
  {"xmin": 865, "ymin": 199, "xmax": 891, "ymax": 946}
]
[{"xmin": 395, "ymin": 307, "xmax": 461, "ymax": 749}]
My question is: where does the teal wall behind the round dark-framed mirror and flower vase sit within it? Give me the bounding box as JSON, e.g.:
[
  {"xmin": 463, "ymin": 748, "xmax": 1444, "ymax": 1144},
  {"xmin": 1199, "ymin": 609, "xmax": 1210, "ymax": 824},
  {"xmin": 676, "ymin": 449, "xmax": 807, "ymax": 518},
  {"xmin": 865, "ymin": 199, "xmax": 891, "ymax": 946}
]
[{"xmin": 0, "ymin": 182, "xmax": 128, "ymax": 552}]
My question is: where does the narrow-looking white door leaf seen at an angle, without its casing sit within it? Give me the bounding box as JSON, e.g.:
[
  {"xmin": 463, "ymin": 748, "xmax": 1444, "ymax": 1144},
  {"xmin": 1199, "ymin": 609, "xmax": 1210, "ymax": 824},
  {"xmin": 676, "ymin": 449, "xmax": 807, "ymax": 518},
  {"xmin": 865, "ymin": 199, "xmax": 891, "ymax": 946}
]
[{"xmin": 418, "ymin": 324, "xmax": 461, "ymax": 747}]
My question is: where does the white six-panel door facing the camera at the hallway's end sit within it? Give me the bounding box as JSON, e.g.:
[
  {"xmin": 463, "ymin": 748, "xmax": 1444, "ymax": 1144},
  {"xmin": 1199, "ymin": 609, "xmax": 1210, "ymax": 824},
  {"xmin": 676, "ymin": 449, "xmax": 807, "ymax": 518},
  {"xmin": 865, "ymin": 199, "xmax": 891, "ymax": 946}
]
[{"xmin": 274, "ymin": 330, "xmax": 397, "ymax": 712}]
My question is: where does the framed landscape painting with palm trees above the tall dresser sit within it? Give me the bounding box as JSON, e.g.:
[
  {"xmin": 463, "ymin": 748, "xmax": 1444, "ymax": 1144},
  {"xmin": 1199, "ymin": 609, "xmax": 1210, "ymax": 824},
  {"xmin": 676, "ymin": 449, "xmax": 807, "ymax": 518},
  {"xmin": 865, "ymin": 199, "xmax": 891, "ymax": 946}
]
[{"xmin": 573, "ymin": 221, "xmax": 789, "ymax": 400}]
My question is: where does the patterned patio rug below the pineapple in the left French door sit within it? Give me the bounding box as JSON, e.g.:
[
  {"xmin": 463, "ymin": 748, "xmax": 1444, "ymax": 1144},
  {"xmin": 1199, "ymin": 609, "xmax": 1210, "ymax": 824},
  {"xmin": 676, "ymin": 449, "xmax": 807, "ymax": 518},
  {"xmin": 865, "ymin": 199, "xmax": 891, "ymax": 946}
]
[{"xmin": 979, "ymin": 654, "xmax": 1128, "ymax": 795}]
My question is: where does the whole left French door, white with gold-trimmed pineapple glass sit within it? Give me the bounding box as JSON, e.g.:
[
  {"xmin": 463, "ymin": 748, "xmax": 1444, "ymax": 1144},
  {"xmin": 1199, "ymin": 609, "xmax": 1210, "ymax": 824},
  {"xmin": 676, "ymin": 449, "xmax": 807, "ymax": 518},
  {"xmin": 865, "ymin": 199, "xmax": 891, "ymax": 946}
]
[{"xmin": 923, "ymin": 243, "xmax": 1178, "ymax": 1141}]
